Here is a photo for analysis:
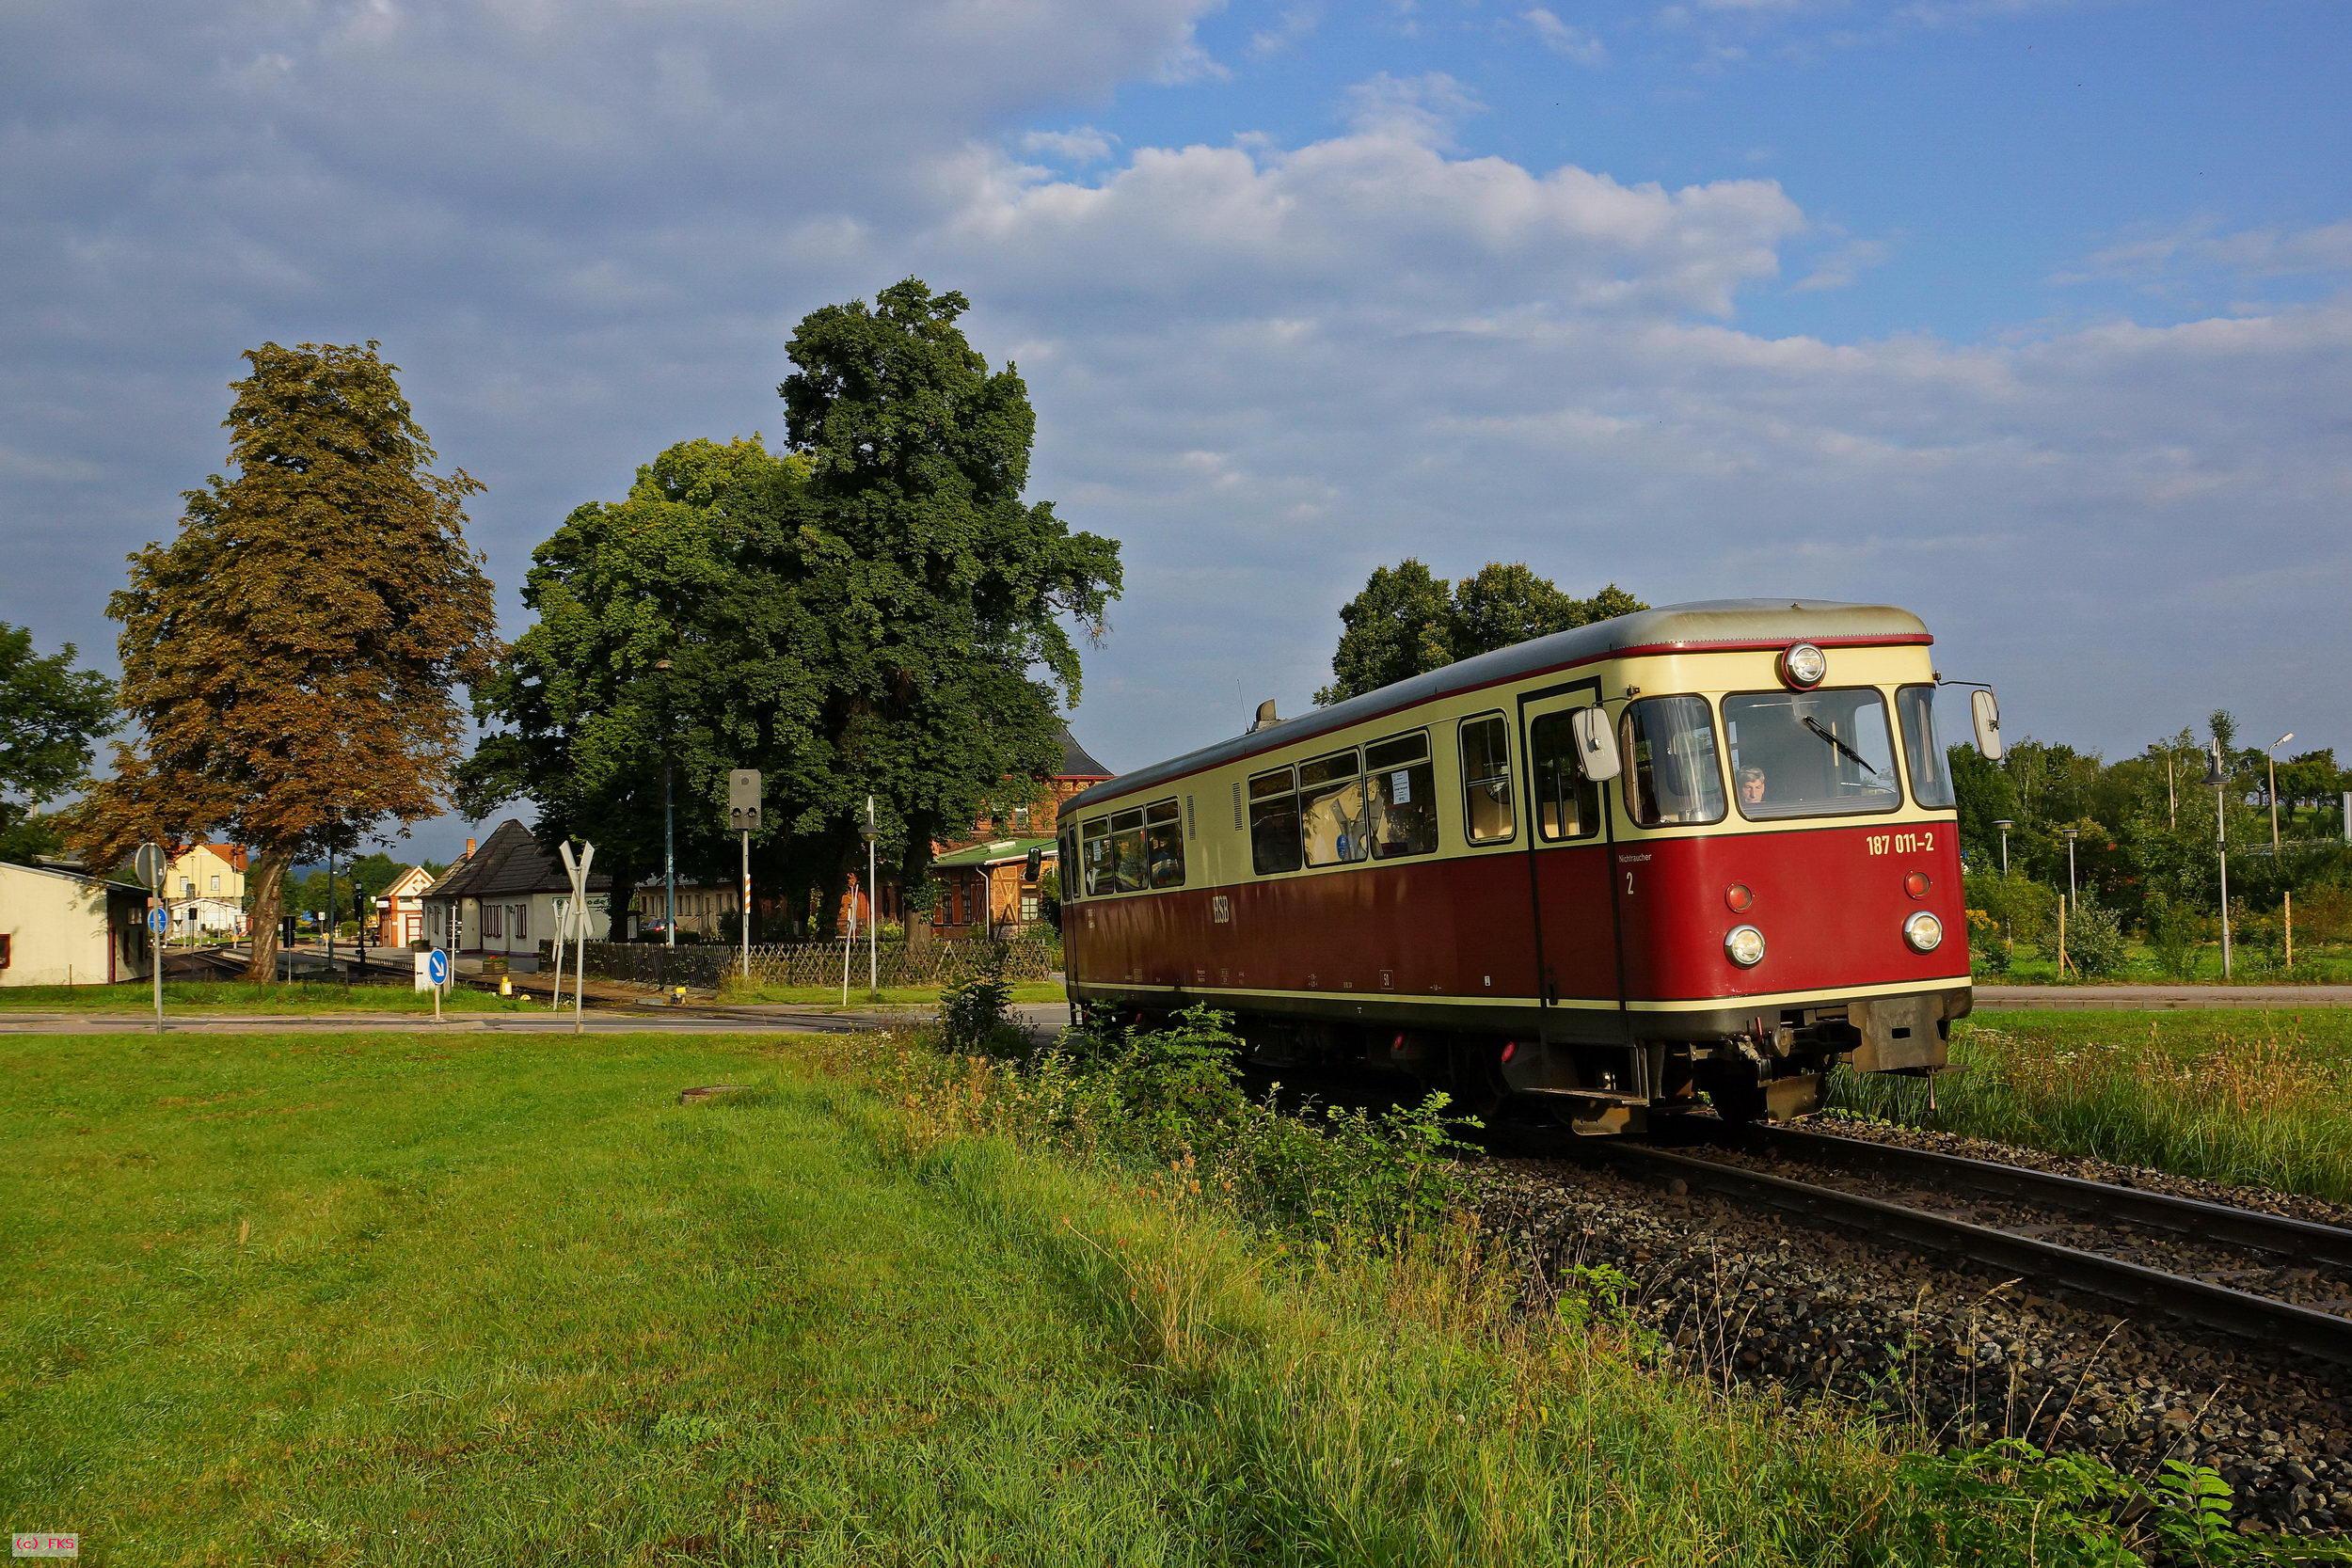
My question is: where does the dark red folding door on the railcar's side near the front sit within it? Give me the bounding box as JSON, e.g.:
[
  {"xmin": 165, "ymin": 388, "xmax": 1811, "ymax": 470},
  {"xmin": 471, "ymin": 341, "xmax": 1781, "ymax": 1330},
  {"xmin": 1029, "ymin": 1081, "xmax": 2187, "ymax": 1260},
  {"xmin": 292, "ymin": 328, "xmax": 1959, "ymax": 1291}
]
[{"xmin": 1519, "ymin": 679, "xmax": 1623, "ymax": 1041}]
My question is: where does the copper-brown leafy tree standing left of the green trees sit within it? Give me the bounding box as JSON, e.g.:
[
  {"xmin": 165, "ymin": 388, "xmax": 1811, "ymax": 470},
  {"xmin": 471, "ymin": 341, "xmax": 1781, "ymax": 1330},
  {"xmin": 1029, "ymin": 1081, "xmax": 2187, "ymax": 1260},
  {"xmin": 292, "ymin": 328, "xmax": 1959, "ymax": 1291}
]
[{"xmin": 75, "ymin": 343, "xmax": 499, "ymax": 980}]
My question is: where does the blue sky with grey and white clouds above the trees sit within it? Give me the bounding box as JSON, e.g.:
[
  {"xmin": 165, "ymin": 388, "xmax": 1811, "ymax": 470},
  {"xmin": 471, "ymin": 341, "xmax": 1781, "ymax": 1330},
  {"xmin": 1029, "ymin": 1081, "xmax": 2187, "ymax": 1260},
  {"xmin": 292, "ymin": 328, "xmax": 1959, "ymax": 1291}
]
[{"xmin": 0, "ymin": 0, "xmax": 2352, "ymax": 856}]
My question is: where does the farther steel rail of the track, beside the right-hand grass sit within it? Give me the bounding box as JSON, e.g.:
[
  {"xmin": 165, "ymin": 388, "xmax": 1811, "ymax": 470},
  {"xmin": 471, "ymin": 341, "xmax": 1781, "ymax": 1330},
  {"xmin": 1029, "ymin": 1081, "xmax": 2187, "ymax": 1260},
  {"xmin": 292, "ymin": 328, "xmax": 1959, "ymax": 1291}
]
[{"xmin": 1734, "ymin": 1126, "xmax": 2352, "ymax": 1270}]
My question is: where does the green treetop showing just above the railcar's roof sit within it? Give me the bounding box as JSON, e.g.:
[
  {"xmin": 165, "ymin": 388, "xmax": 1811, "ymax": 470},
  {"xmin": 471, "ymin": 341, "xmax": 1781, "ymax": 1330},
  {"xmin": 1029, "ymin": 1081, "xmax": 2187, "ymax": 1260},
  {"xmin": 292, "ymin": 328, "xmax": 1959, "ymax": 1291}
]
[{"xmin": 1315, "ymin": 557, "xmax": 1649, "ymax": 705}]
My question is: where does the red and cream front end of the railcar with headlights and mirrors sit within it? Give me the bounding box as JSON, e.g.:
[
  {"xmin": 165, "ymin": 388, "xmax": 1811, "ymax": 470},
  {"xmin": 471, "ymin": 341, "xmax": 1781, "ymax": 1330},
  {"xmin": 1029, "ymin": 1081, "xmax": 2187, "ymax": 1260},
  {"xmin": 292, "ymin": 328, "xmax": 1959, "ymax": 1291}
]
[{"xmin": 1499, "ymin": 641, "xmax": 2002, "ymax": 1133}]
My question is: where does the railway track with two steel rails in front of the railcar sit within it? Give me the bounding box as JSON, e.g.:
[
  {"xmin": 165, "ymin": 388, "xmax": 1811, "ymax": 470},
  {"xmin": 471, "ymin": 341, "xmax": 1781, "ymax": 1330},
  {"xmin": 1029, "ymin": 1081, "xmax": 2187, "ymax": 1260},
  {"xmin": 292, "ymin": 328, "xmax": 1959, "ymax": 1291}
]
[{"xmin": 1590, "ymin": 1126, "xmax": 2352, "ymax": 1369}]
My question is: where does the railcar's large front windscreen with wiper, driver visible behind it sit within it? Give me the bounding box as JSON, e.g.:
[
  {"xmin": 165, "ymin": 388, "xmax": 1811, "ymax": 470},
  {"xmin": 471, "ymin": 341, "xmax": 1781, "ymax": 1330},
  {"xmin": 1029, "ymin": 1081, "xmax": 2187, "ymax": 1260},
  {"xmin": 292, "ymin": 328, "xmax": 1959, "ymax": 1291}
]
[{"xmin": 1724, "ymin": 687, "xmax": 1903, "ymax": 820}]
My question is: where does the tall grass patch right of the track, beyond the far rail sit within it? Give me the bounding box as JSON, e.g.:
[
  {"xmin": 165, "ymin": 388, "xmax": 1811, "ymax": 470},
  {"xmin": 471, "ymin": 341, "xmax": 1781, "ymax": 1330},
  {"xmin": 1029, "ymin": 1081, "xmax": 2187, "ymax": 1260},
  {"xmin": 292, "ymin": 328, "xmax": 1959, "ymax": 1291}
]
[{"xmin": 1833, "ymin": 1006, "xmax": 2352, "ymax": 1201}]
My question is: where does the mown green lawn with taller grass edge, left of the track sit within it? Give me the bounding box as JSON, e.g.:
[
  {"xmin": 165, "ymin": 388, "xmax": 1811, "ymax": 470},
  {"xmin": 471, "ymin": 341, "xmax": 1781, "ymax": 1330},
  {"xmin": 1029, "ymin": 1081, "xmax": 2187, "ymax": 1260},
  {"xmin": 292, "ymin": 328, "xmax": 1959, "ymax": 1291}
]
[{"xmin": 0, "ymin": 1035, "xmax": 2201, "ymax": 1566}]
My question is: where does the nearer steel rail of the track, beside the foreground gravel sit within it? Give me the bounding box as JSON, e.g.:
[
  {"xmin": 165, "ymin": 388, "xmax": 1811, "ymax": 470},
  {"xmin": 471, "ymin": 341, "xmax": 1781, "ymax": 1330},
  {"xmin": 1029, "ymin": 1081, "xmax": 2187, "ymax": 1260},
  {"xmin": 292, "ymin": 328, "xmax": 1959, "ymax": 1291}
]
[{"xmin": 1593, "ymin": 1143, "xmax": 2352, "ymax": 1366}]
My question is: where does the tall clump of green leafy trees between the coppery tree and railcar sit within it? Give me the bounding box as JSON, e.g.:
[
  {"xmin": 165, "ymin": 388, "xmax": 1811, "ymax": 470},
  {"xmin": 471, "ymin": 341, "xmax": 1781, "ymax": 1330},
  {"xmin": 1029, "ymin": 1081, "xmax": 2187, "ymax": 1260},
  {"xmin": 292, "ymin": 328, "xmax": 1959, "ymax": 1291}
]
[{"xmin": 466, "ymin": 279, "xmax": 1120, "ymax": 940}]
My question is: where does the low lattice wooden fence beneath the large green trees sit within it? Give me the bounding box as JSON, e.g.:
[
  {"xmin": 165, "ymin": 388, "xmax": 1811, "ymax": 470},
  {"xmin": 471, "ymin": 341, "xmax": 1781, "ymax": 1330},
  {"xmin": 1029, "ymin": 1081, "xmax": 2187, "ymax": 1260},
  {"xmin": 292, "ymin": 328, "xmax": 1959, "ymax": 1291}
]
[{"xmin": 539, "ymin": 931, "xmax": 1061, "ymax": 990}]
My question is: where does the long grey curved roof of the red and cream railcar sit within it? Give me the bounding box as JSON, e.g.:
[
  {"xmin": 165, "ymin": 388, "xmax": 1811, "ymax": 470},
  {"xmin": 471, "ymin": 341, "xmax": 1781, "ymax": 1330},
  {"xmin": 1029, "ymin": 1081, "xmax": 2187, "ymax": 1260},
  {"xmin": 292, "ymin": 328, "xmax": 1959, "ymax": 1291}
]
[{"xmin": 1063, "ymin": 599, "xmax": 1929, "ymax": 811}]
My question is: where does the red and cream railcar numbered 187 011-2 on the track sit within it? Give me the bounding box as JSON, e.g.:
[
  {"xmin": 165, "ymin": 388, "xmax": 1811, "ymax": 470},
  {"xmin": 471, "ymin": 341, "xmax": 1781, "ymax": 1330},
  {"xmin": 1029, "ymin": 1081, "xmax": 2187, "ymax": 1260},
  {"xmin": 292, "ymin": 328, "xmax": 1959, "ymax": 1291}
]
[{"xmin": 1061, "ymin": 599, "xmax": 1997, "ymax": 1131}]
